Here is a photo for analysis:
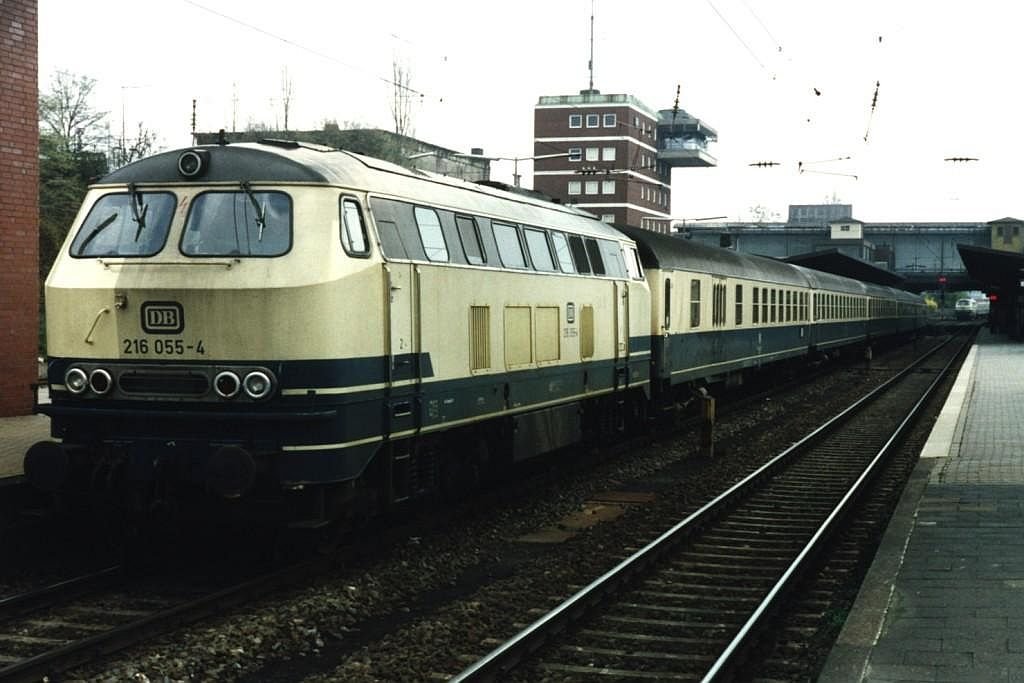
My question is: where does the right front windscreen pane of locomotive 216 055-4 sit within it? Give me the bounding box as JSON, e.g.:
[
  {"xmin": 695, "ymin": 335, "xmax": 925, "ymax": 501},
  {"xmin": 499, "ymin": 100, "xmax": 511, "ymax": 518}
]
[{"xmin": 180, "ymin": 185, "xmax": 292, "ymax": 256}]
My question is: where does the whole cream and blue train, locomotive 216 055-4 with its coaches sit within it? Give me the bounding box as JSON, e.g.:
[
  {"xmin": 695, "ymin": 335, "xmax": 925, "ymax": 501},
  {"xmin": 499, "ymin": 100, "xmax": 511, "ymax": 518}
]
[{"xmin": 25, "ymin": 141, "xmax": 923, "ymax": 524}]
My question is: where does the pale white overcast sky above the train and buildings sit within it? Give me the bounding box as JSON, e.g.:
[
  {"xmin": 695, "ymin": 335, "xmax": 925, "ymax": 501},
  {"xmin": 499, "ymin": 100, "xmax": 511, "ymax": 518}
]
[{"xmin": 39, "ymin": 0, "xmax": 1024, "ymax": 221}]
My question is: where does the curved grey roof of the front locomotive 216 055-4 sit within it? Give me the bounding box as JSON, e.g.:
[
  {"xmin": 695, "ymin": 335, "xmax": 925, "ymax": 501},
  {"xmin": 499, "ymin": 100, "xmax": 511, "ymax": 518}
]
[{"xmin": 97, "ymin": 140, "xmax": 622, "ymax": 239}]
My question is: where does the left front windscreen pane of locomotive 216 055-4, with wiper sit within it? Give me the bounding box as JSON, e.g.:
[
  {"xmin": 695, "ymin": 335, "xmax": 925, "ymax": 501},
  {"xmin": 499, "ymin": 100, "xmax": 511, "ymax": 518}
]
[{"xmin": 71, "ymin": 190, "xmax": 177, "ymax": 258}]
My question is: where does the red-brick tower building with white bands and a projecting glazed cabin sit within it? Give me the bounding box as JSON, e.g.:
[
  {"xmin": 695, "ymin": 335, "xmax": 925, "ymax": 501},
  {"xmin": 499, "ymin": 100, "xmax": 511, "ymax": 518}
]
[{"xmin": 534, "ymin": 89, "xmax": 717, "ymax": 232}]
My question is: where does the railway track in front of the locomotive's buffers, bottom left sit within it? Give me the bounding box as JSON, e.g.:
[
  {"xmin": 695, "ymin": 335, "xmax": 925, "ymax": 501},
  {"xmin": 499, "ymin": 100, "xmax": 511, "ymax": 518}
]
[{"xmin": 0, "ymin": 559, "xmax": 323, "ymax": 682}]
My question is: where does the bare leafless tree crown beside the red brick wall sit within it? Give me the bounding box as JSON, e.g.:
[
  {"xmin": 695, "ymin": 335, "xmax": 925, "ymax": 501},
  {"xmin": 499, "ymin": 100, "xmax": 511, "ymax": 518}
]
[{"xmin": 39, "ymin": 72, "xmax": 109, "ymax": 152}]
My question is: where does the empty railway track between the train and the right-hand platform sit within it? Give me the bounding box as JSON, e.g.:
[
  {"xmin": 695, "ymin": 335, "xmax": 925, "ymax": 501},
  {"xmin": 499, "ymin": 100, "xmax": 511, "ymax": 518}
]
[{"xmin": 454, "ymin": 331, "xmax": 963, "ymax": 681}]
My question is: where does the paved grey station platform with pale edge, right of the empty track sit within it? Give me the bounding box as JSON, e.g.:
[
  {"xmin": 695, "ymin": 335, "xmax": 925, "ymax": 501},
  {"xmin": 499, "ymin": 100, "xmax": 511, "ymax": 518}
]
[{"xmin": 818, "ymin": 329, "xmax": 1024, "ymax": 683}]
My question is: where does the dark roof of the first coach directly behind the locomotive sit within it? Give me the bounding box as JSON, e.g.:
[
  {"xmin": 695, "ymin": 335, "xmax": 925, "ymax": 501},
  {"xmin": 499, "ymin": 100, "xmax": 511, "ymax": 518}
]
[{"xmin": 620, "ymin": 227, "xmax": 808, "ymax": 287}]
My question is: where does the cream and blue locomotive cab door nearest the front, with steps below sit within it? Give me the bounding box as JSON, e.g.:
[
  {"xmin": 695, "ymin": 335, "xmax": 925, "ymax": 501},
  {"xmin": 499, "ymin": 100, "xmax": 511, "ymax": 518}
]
[{"xmin": 384, "ymin": 262, "xmax": 421, "ymax": 434}]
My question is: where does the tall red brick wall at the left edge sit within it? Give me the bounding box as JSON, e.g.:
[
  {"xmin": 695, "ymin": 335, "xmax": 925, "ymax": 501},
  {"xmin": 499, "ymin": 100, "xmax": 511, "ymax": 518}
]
[{"xmin": 0, "ymin": 0, "xmax": 39, "ymax": 416}]
